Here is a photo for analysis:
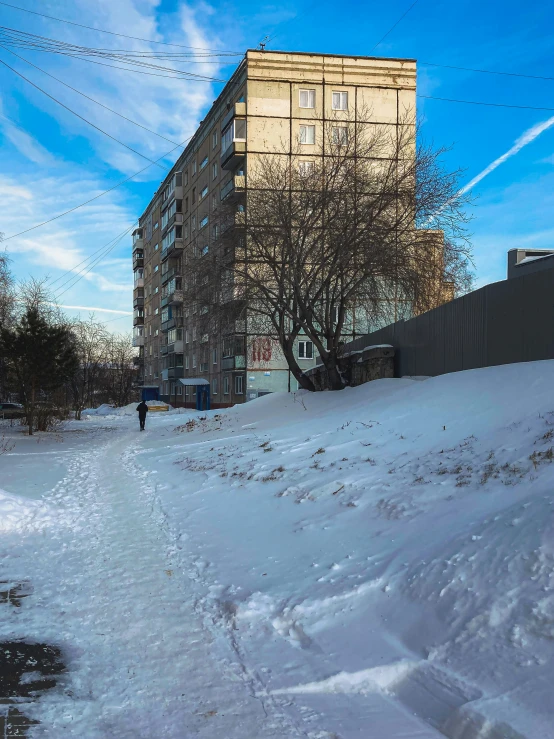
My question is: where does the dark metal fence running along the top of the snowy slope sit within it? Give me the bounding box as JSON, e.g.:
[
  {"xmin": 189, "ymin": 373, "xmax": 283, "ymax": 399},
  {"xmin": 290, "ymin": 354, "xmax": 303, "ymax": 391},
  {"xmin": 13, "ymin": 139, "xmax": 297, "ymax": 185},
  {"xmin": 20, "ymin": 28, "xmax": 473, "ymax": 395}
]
[{"xmin": 345, "ymin": 269, "xmax": 554, "ymax": 377}]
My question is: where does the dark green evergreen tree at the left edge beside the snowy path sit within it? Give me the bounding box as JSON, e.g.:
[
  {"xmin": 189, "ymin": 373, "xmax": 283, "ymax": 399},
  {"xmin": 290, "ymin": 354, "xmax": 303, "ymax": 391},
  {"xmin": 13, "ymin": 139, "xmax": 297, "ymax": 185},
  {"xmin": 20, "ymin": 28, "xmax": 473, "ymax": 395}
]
[{"xmin": 0, "ymin": 307, "xmax": 78, "ymax": 435}]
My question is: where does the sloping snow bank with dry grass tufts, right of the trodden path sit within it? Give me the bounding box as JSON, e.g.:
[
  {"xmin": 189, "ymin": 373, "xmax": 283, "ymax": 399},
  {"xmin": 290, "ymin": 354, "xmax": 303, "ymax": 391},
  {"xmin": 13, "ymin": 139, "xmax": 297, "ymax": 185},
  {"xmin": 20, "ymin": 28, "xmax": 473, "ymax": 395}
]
[{"xmin": 141, "ymin": 361, "xmax": 554, "ymax": 739}]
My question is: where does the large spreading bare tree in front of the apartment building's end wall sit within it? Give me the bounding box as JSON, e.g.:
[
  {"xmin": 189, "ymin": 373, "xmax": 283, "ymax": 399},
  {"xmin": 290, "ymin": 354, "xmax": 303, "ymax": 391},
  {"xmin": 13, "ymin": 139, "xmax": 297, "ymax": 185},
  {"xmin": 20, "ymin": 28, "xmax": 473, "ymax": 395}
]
[{"xmin": 183, "ymin": 113, "xmax": 471, "ymax": 390}]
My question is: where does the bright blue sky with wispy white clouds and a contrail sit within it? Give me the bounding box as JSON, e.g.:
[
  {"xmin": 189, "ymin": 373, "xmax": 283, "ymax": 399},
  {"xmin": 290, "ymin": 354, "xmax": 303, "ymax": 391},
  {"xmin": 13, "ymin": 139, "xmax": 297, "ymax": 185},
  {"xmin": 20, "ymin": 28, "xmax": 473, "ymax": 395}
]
[{"xmin": 0, "ymin": 0, "xmax": 554, "ymax": 330}]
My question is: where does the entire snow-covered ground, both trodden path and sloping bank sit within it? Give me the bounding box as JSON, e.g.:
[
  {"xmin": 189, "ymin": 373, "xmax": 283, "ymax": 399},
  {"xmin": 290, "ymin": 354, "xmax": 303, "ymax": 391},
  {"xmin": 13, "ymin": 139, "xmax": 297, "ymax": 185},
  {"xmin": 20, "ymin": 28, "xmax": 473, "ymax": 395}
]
[{"xmin": 0, "ymin": 362, "xmax": 554, "ymax": 739}]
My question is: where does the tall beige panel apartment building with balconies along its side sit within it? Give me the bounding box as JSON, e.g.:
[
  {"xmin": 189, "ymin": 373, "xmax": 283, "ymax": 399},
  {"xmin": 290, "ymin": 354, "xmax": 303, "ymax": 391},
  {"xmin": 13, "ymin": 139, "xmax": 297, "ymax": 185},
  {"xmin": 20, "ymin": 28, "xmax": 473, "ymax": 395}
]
[{"xmin": 133, "ymin": 50, "xmax": 416, "ymax": 408}]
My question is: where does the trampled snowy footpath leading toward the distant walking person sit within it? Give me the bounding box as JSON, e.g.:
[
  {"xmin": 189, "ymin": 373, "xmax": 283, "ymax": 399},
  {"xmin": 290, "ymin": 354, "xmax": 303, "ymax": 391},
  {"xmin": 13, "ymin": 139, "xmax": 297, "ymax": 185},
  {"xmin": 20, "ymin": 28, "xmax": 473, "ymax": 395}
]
[{"xmin": 2, "ymin": 432, "xmax": 303, "ymax": 739}]
